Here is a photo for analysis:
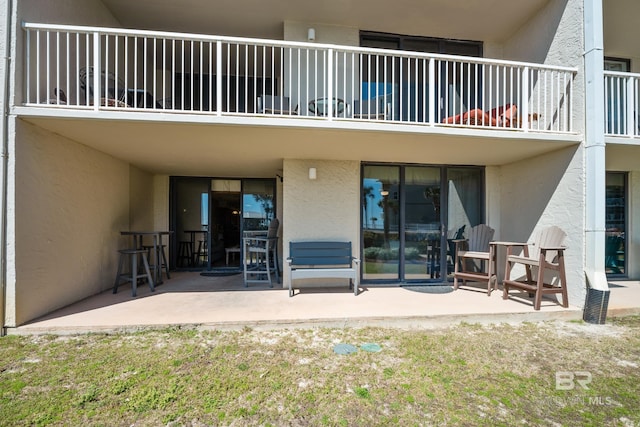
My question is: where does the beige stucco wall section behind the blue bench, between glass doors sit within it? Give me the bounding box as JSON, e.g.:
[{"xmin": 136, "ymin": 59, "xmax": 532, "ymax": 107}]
[{"xmin": 282, "ymin": 159, "xmax": 360, "ymax": 286}]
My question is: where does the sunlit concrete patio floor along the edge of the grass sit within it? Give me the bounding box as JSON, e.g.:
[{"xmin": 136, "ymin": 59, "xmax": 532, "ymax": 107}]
[{"xmin": 8, "ymin": 272, "xmax": 640, "ymax": 334}]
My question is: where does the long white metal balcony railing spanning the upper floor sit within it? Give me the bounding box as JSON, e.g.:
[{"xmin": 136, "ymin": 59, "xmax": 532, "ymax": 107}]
[{"xmin": 23, "ymin": 23, "xmax": 576, "ymax": 133}]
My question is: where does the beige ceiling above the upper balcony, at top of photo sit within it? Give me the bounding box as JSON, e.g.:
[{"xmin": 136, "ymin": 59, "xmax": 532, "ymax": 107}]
[{"xmin": 102, "ymin": 0, "xmax": 549, "ymax": 42}]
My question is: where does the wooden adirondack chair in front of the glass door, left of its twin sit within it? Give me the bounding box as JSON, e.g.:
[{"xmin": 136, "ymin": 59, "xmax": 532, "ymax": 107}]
[{"xmin": 453, "ymin": 224, "xmax": 498, "ymax": 295}]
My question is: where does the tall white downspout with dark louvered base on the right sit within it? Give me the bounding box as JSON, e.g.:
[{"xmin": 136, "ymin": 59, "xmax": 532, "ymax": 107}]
[{"xmin": 583, "ymin": 0, "xmax": 609, "ymax": 323}]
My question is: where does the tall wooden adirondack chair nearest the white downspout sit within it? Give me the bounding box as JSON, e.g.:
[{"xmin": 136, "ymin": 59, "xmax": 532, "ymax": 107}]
[{"xmin": 501, "ymin": 226, "xmax": 569, "ymax": 310}]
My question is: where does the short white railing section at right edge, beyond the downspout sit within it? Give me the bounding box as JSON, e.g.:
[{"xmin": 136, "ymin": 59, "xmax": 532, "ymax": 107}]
[{"xmin": 604, "ymin": 71, "xmax": 640, "ymax": 137}]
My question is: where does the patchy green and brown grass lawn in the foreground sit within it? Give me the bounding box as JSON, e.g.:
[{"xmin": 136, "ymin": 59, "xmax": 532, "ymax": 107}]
[{"xmin": 0, "ymin": 317, "xmax": 640, "ymax": 427}]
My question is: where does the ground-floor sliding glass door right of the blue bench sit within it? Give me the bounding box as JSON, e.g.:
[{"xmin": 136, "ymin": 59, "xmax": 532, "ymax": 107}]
[{"xmin": 362, "ymin": 165, "xmax": 484, "ymax": 282}]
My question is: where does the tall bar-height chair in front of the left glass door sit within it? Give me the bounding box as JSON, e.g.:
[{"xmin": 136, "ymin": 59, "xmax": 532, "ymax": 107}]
[{"xmin": 242, "ymin": 218, "xmax": 280, "ymax": 287}]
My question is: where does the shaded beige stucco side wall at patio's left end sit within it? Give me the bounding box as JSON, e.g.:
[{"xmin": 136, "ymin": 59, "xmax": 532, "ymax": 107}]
[{"xmin": 7, "ymin": 121, "xmax": 130, "ymax": 326}]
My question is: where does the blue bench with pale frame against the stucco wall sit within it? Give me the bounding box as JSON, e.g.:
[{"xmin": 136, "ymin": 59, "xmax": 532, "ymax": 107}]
[{"xmin": 287, "ymin": 242, "xmax": 360, "ymax": 297}]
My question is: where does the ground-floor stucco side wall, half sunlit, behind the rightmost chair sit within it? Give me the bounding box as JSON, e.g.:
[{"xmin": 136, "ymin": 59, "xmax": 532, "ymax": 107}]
[{"xmin": 499, "ymin": 146, "xmax": 586, "ymax": 307}]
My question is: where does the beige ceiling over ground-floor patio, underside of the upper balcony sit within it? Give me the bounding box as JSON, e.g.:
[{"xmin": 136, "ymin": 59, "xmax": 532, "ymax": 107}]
[{"xmin": 23, "ymin": 117, "xmax": 578, "ymax": 177}]
